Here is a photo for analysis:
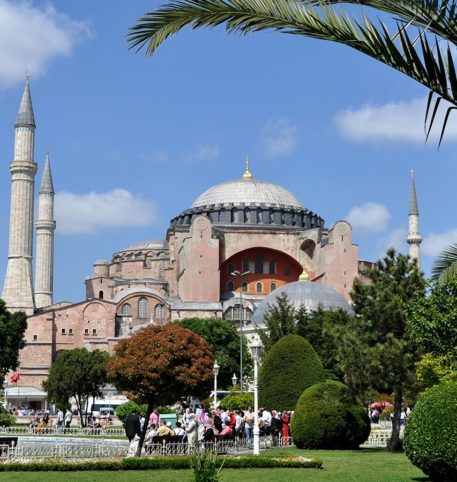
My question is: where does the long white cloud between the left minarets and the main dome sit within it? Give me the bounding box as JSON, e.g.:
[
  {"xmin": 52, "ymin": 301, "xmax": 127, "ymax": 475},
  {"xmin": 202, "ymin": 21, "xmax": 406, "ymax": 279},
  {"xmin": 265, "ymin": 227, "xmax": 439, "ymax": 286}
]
[{"xmin": 55, "ymin": 189, "xmax": 157, "ymax": 234}]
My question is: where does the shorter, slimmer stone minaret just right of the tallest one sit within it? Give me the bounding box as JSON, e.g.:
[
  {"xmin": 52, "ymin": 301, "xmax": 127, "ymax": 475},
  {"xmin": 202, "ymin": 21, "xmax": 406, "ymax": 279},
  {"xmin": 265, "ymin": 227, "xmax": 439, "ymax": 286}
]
[{"xmin": 35, "ymin": 151, "xmax": 56, "ymax": 308}]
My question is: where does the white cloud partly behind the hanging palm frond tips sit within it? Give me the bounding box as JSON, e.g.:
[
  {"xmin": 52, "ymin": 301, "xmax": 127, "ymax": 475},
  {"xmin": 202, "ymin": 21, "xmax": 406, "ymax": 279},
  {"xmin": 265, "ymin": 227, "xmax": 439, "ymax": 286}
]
[{"xmin": 333, "ymin": 98, "xmax": 457, "ymax": 143}]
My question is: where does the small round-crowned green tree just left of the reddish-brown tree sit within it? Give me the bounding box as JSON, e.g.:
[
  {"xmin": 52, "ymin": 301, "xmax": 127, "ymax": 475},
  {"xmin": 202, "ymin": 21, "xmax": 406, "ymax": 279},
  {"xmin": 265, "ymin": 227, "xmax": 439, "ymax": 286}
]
[{"xmin": 43, "ymin": 348, "xmax": 109, "ymax": 426}]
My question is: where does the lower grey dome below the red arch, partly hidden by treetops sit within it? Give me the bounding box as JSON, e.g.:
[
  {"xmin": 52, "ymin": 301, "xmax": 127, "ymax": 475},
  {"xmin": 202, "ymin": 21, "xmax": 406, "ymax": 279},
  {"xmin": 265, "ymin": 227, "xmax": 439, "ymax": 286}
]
[{"xmin": 252, "ymin": 281, "xmax": 352, "ymax": 325}]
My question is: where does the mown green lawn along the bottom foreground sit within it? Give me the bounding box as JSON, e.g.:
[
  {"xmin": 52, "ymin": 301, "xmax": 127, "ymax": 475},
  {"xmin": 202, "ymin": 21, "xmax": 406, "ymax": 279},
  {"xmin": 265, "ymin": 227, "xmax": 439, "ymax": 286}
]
[{"xmin": 0, "ymin": 448, "xmax": 428, "ymax": 482}]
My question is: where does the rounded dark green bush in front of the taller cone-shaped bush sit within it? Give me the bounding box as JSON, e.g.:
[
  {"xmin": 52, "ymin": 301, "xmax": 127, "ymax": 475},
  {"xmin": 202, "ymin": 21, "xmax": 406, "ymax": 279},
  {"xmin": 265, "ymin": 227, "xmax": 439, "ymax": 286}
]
[{"xmin": 290, "ymin": 380, "xmax": 370, "ymax": 450}]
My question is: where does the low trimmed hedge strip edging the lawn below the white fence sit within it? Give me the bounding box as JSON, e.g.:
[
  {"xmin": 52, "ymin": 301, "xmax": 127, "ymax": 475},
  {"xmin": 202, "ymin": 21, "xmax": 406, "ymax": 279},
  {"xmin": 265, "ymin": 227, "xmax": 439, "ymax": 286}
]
[{"xmin": 0, "ymin": 455, "xmax": 322, "ymax": 472}]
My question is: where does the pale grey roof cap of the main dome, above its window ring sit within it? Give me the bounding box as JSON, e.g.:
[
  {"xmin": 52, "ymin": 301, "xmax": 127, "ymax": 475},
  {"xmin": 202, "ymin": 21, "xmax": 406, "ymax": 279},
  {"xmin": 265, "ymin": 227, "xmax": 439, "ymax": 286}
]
[{"xmin": 191, "ymin": 178, "xmax": 305, "ymax": 210}]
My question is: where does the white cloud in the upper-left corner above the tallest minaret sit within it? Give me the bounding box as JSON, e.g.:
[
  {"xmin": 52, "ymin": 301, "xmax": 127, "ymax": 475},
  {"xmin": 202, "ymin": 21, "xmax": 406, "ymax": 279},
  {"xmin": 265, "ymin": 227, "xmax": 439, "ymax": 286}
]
[{"xmin": 0, "ymin": 0, "xmax": 90, "ymax": 88}]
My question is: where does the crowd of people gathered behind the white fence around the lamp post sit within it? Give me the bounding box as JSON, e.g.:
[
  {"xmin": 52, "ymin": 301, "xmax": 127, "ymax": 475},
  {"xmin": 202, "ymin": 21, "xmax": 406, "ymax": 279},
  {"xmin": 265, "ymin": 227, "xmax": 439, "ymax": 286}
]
[{"xmin": 125, "ymin": 406, "xmax": 293, "ymax": 450}]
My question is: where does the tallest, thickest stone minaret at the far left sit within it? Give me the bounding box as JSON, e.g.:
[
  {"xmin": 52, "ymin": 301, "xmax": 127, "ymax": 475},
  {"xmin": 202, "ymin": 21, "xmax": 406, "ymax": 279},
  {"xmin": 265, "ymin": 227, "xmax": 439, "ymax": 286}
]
[{"xmin": 3, "ymin": 74, "xmax": 37, "ymax": 315}]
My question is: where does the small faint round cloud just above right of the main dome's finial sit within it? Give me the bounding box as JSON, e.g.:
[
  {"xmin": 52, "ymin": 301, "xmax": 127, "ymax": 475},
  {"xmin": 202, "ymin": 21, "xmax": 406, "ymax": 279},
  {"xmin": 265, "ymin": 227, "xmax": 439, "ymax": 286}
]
[{"xmin": 259, "ymin": 119, "xmax": 298, "ymax": 158}]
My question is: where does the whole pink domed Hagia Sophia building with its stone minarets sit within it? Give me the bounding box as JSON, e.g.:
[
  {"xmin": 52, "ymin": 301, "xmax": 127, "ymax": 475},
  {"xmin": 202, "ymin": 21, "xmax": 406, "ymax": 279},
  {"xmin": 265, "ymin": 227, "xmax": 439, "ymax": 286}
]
[{"xmin": 3, "ymin": 78, "xmax": 422, "ymax": 403}]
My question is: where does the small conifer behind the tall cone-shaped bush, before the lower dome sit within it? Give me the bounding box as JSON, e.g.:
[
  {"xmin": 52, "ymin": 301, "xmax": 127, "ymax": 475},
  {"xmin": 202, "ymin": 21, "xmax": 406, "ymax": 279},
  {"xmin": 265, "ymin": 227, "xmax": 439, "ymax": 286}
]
[{"xmin": 257, "ymin": 292, "xmax": 296, "ymax": 352}]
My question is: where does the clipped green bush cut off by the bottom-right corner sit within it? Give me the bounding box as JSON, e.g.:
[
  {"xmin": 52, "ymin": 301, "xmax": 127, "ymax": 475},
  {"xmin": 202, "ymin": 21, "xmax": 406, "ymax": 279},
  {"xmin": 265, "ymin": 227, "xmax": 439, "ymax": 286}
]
[{"xmin": 403, "ymin": 381, "xmax": 457, "ymax": 481}]
